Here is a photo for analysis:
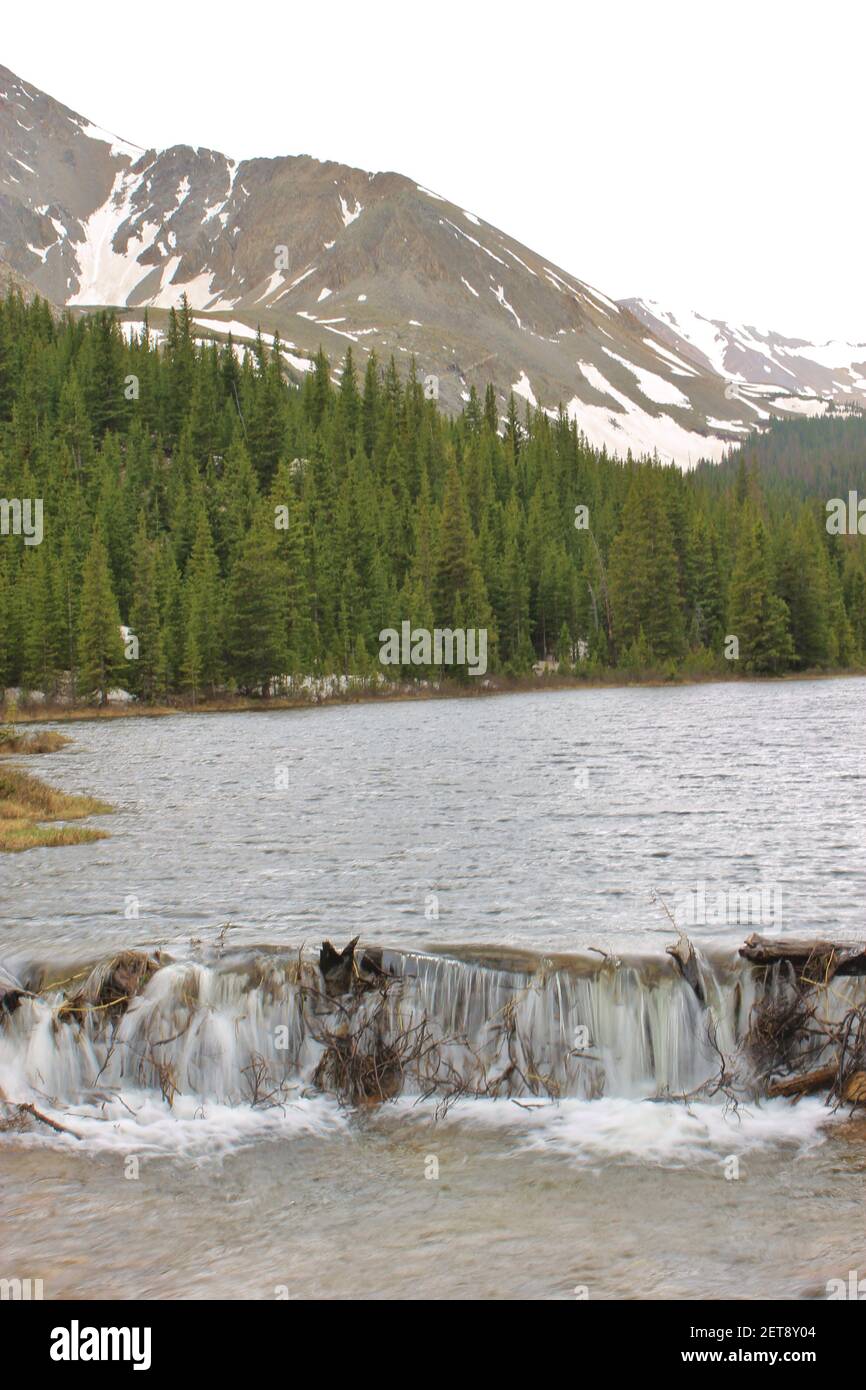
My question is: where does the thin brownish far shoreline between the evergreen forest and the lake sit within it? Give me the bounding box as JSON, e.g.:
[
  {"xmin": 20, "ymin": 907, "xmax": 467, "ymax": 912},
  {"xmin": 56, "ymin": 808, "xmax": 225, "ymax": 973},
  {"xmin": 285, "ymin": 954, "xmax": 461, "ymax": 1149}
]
[{"xmin": 0, "ymin": 667, "xmax": 866, "ymax": 724}]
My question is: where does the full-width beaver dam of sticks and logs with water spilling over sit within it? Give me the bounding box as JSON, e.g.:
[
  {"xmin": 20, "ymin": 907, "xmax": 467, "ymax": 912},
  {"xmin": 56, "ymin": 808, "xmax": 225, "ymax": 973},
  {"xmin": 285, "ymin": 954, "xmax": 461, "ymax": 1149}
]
[{"xmin": 0, "ymin": 935, "xmax": 866, "ymax": 1134}]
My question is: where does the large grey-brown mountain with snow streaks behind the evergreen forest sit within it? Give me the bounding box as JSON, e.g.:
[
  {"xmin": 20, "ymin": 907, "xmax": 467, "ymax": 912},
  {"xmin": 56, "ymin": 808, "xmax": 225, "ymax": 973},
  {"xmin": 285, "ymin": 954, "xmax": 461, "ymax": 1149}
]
[{"xmin": 0, "ymin": 67, "xmax": 856, "ymax": 466}]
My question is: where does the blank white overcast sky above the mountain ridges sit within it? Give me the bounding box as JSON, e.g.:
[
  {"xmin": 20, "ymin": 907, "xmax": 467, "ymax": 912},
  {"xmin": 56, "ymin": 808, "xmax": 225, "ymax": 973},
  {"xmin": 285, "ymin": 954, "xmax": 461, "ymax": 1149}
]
[{"xmin": 6, "ymin": 0, "xmax": 866, "ymax": 341}]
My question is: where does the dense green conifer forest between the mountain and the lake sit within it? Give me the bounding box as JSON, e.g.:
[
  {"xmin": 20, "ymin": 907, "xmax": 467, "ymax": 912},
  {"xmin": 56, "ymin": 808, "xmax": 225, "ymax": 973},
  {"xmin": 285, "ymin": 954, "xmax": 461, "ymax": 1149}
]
[{"xmin": 0, "ymin": 293, "xmax": 866, "ymax": 701}]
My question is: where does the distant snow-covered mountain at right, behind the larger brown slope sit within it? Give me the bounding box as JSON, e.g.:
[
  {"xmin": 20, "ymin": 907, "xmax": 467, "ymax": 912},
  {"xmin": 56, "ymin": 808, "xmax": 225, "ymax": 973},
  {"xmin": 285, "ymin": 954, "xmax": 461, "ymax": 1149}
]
[{"xmin": 620, "ymin": 299, "xmax": 866, "ymax": 414}]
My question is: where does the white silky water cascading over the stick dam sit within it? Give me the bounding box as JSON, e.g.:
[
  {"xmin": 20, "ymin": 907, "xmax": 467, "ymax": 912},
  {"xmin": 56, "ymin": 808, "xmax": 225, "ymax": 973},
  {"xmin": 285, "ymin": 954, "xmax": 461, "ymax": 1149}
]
[{"xmin": 0, "ymin": 948, "xmax": 866, "ymax": 1139}]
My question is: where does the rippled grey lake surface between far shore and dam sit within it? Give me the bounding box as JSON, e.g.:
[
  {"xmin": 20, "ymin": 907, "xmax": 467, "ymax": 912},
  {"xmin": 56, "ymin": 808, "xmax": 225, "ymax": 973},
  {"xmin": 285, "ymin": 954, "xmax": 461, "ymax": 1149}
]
[{"xmin": 0, "ymin": 680, "xmax": 866, "ymax": 951}]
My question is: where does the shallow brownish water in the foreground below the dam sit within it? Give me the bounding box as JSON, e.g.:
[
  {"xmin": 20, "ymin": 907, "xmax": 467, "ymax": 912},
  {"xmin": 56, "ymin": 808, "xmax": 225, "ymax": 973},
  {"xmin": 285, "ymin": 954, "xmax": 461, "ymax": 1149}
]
[{"xmin": 0, "ymin": 1102, "xmax": 866, "ymax": 1301}]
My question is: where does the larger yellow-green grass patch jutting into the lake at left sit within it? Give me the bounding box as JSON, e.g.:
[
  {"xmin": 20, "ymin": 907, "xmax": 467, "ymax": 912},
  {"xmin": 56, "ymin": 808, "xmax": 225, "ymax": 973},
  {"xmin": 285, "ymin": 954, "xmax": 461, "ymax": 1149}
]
[{"xmin": 0, "ymin": 767, "xmax": 113, "ymax": 852}]
